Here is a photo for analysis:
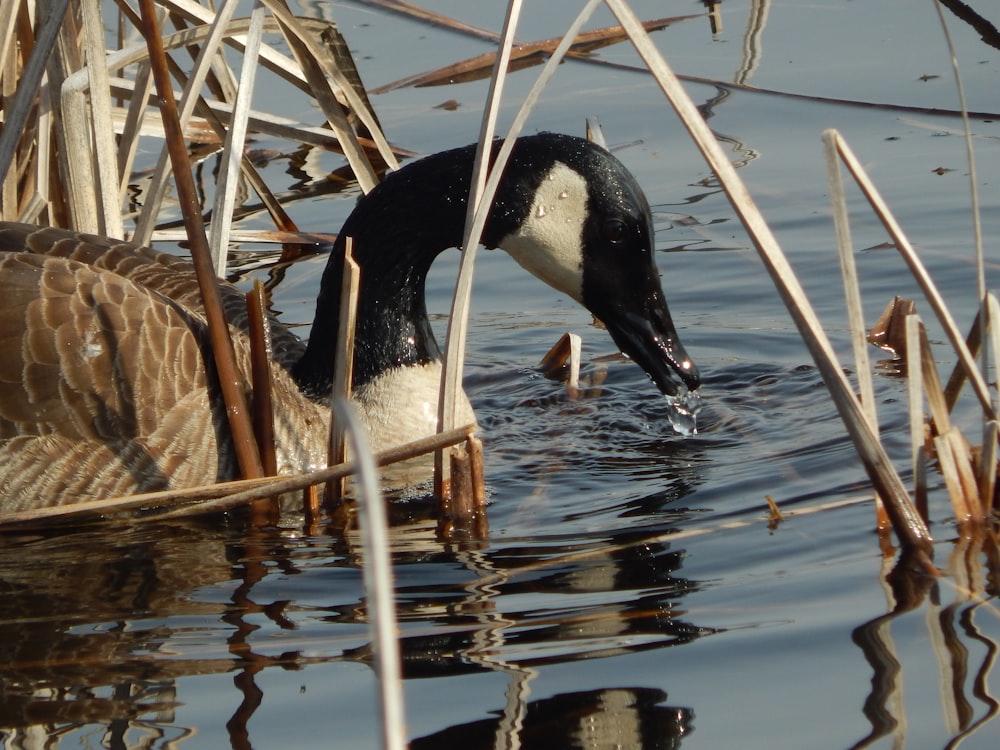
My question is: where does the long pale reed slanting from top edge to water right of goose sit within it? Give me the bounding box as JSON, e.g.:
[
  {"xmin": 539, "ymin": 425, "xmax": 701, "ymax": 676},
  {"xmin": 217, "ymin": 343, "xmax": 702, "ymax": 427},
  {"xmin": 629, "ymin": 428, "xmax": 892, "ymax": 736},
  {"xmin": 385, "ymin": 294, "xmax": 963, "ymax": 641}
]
[{"xmin": 605, "ymin": 0, "xmax": 934, "ymax": 570}]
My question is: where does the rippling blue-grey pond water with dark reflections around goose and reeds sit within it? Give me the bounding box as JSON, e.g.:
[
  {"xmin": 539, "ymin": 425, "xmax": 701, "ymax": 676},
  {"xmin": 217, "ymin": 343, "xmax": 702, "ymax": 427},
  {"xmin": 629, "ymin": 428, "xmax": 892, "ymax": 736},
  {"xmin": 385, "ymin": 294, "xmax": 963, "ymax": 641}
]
[{"xmin": 0, "ymin": 0, "xmax": 1000, "ymax": 748}]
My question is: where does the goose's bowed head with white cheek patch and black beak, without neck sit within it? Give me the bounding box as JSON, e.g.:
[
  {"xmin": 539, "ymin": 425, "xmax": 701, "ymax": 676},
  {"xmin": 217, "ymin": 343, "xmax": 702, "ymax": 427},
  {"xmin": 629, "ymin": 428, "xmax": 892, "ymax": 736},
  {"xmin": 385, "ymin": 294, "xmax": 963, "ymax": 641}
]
[{"xmin": 485, "ymin": 134, "xmax": 700, "ymax": 396}]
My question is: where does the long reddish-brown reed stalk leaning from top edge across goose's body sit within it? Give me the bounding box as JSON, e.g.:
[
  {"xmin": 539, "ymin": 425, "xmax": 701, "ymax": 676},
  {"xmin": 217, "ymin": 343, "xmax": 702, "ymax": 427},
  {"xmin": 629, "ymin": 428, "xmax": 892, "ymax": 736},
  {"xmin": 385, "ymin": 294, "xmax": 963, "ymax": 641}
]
[{"xmin": 139, "ymin": 0, "xmax": 264, "ymax": 478}]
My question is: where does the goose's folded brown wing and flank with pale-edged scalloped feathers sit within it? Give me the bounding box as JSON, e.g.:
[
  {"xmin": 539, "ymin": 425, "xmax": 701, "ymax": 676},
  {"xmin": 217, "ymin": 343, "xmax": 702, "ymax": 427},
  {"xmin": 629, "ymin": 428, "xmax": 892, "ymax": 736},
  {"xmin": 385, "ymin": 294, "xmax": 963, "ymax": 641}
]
[{"xmin": 0, "ymin": 253, "xmax": 232, "ymax": 509}]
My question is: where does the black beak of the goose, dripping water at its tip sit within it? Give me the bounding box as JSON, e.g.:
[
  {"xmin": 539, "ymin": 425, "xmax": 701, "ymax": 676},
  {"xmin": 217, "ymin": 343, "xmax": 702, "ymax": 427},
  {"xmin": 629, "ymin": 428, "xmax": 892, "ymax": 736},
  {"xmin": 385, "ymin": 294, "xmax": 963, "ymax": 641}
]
[{"xmin": 592, "ymin": 290, "xmax": 701, "ymax": 396}]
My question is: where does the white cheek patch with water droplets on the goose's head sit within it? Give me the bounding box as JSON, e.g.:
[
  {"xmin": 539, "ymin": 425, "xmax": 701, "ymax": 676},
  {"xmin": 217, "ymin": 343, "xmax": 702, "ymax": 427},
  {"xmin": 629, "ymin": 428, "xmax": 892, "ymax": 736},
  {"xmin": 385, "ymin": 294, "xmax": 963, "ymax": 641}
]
[{"xmin": 500, "ymin": 162, "xmax": 587, "ymax": 302}]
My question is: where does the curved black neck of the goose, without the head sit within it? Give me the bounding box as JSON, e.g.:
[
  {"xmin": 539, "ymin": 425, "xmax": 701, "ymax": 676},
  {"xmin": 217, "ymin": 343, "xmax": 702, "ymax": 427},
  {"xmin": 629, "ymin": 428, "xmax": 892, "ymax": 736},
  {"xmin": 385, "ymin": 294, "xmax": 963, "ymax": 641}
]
[{"xmin": 293, "ymin": 141, "xmax": 526, "ymax": 398}]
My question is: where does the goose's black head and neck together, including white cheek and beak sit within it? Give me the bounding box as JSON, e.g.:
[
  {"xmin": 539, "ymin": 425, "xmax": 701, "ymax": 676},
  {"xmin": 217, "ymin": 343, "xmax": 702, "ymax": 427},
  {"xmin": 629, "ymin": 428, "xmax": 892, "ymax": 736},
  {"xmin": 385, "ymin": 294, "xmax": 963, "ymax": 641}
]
[{"xmin": 292, "ymin": 133, "xmax": 700, "ymax": 408}]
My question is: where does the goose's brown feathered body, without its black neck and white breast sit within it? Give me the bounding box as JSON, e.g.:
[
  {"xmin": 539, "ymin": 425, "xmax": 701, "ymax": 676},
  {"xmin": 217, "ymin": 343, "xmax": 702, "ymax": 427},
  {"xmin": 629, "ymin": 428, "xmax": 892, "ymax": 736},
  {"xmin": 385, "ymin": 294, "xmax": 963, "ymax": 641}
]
[{"xmin": 0, "ymin": 224, "xmax": 329, "ymax": 513}]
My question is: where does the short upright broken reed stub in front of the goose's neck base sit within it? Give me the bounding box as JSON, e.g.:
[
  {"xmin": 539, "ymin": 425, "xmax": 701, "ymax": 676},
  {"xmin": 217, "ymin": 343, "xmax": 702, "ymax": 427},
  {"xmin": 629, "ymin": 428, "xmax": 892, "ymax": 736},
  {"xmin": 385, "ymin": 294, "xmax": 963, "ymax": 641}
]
[{"xmin": 326, "ymin": 237, "xmax": 361, "ymax": 509}]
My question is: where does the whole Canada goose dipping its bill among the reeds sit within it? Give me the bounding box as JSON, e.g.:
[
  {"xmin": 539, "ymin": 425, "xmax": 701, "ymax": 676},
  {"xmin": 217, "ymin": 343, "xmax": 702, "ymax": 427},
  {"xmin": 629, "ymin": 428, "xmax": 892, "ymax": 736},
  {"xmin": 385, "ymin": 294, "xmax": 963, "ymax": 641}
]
[{"xmin": 0, "ymin": 133, "xmax": 699, "ymax": 511}]
